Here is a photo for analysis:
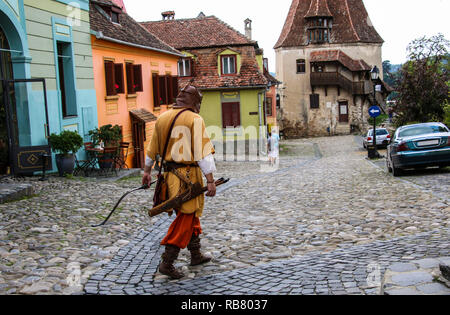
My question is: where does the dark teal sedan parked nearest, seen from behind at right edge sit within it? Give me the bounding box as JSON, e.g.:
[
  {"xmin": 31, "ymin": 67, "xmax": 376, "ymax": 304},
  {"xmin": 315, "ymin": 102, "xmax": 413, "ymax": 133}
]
[{"xmin": 386, "ymin": 123, "xmax": 450, "ymax": 176}]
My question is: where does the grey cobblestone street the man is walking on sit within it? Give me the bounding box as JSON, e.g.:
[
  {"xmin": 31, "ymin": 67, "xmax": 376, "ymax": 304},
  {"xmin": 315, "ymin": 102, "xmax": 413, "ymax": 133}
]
[{"xmin": 0, "ymin": 136, "xmax": 450, "ymax": 294}]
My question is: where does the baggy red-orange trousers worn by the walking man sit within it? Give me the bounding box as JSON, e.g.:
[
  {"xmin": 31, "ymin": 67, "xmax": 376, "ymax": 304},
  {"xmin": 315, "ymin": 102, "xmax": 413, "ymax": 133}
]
[{"xmin": 161, "ymin": 212, "xmax": 202, "ymax": 249}]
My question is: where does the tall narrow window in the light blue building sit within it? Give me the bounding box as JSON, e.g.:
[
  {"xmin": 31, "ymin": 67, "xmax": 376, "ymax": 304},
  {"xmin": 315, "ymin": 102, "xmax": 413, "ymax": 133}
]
[{"xmin": 56, "ymin": 42, "xmax": 77, "ymax": 118}]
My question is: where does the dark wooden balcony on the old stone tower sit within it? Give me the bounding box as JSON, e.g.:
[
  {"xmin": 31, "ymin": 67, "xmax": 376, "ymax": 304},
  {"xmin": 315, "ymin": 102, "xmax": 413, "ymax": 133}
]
[{"xmin": 311, "ymin": 72, "xmax": 371, "ymax": 95}]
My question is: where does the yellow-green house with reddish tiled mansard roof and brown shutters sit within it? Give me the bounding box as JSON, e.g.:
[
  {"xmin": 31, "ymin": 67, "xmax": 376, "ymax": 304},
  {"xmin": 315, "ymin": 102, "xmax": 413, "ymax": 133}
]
[{"xmin": 141, "ymin": 11, "xmax": 269, "ymax": 157}]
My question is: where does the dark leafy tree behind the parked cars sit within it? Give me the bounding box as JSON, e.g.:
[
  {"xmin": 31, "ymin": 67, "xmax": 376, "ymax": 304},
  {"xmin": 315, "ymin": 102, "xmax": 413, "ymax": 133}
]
[{"xmin": 394, "ymin": 34, "xmax": 450, "ymax": 126}]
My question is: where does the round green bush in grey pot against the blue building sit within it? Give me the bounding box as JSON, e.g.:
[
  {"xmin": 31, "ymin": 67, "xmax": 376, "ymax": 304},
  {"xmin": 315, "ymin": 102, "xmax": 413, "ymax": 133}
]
[{"xmin": 49, "ymin": 130, "xmax": 83, "ymax": 177}]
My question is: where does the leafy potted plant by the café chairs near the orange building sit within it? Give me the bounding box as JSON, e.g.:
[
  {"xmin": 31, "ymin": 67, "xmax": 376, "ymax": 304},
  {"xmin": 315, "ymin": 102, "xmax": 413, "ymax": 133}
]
[{"xmin": 89, "ymin": 125, "xmax": 122, "ymax": 169}]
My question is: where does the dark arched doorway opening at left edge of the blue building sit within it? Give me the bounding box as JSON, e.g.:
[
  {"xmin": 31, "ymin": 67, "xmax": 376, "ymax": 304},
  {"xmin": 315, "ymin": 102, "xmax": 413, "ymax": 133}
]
[{"xmin": 0, "ymin": 27, "xmax": 13, "ymax": 176}]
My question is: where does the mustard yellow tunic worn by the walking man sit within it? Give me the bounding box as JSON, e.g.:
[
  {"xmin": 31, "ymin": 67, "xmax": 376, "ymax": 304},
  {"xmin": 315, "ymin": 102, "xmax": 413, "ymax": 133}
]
[{"xmin": 147, "ymin": 109, "xmax": 214, "ymax": 218}]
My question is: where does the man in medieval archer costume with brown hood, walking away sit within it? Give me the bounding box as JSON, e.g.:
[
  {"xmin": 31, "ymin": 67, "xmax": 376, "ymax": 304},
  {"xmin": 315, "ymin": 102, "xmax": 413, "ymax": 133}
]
[{"xmin": 143, "ymin": 85, "xmax": 216, "ymax": 279}]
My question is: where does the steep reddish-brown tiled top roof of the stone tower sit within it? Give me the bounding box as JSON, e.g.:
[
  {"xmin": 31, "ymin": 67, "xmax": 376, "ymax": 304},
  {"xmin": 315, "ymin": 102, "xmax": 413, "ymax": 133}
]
[{"xmin": 275, "ymin": 0, "xmax": 383, "ymax": 49}]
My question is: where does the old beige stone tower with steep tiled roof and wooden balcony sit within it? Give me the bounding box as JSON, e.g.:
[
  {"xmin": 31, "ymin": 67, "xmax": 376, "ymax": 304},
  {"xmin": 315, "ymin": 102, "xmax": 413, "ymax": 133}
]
[{"xmin": 275, "ymin": 0, "xmax": 385, "ymax": 137}]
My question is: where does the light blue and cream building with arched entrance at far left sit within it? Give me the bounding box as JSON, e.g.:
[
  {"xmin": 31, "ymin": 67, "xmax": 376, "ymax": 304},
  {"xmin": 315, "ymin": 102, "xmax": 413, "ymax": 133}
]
[{"xmin": 0, "ymin": 0, "xmax": 97, "ymax": 175}]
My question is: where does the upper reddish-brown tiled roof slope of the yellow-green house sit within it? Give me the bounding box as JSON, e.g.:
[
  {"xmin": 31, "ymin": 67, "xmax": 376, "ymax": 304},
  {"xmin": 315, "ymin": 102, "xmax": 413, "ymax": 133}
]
[{"xmin": 141, "ymin": 15, "xmax": 257, "ymax": 49}]
